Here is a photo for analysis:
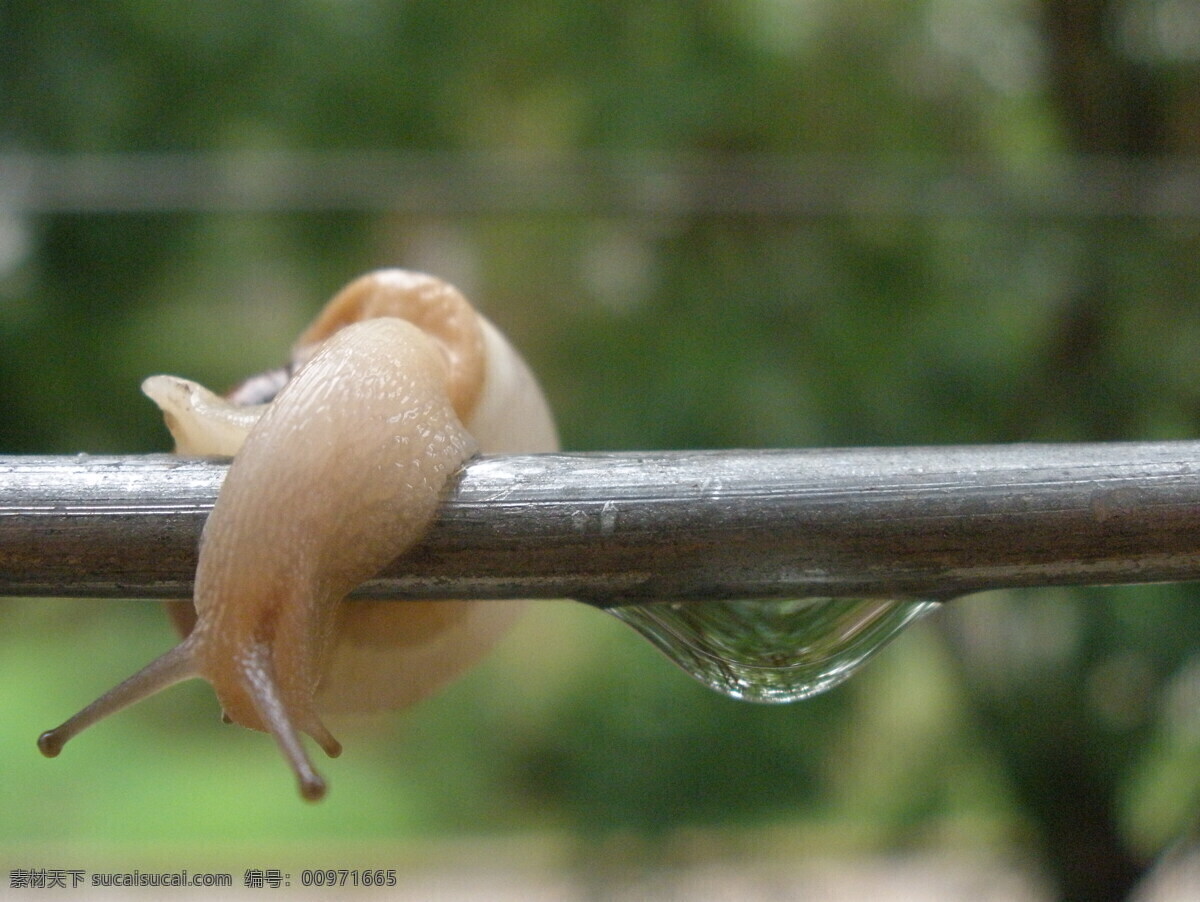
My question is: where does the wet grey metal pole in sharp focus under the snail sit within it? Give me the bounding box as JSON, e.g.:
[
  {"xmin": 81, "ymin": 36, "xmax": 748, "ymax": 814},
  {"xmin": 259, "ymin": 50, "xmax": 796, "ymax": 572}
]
[{"xmin": 0, "ymin": 441, "xmax": 1200, "ymax": 605}]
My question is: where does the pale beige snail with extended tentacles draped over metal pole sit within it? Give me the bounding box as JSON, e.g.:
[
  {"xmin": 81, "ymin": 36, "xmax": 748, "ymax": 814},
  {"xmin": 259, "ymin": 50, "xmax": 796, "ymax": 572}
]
[{"xmin": 38, "ymin": 270, "xmax": 557, "ymax": 800}]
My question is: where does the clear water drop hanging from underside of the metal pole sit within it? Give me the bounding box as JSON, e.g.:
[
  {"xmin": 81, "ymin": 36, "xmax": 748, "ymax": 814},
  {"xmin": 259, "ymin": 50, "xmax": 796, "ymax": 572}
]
[{"xmin": 608, "ymin": 597, "xmax": 938, "ymax": 703}]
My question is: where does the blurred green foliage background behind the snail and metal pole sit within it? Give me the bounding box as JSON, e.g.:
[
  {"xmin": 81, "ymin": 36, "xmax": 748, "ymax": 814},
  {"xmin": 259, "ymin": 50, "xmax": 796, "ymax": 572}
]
[{"xmin": 0, "ymin": 0, "xmax": 1200, "ymax": 901}]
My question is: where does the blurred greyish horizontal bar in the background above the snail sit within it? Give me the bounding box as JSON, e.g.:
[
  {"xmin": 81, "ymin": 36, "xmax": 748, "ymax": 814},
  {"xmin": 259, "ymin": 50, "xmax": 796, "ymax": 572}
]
[{"xmin": 7, "ymin": 151, "xmax": 1200, "ymax": 218}]
